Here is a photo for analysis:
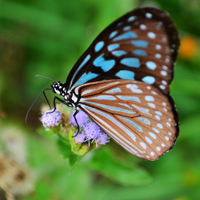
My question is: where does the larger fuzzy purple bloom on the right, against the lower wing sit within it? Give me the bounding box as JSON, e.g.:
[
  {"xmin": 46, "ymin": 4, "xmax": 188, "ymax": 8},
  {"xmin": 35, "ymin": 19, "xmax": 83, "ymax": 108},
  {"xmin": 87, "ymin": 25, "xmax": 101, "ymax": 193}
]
[{"xmin": 70, "ymin": 111, "xmax": 110, "ymax": 147}]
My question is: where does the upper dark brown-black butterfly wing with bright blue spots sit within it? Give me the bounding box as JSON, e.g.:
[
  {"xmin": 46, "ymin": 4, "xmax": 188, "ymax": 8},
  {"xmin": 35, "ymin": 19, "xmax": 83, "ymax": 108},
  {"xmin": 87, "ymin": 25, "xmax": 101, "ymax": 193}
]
[{"xmin": 66, "ymin": 8, "xmax": 180, "ymax": 94}]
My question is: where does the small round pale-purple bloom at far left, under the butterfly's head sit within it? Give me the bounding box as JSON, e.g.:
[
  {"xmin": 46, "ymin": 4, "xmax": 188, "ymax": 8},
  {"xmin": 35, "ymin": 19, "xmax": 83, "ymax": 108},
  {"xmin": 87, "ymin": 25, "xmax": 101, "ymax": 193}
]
[{"xmin": 40, "ymin": 109, "xmax": 62, "ymax": 128}]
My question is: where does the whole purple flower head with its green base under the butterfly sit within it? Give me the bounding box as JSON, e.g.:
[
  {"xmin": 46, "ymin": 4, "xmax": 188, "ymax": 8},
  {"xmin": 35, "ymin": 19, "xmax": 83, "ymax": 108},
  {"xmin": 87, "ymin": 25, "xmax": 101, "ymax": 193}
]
[{"xmin": 40, "ymin": 104, "xmax": 110, "ymax": 158}]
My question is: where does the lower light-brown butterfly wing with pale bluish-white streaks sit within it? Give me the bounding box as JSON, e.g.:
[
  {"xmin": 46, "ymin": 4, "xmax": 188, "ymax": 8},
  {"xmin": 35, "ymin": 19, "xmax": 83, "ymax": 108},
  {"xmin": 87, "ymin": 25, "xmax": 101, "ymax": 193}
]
[{"xmin": 73, "ymin": 79, "xmax": 179, "ymax": 160}]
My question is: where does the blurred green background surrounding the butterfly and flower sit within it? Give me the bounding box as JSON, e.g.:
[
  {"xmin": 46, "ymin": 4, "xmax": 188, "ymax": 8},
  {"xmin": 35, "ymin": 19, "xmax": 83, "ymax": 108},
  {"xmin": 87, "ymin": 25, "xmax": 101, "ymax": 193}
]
[{"xmin": 0, "ymin": 0, "xmax": 200, "ymax": 200}]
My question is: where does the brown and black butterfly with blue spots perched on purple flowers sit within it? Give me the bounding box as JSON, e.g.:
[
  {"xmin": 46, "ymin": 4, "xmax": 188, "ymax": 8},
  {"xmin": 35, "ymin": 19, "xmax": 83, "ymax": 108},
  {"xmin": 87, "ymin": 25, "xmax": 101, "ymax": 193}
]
[{"xmin": 38, "ymin": 7, "xmax": 180, "ymax": 160}]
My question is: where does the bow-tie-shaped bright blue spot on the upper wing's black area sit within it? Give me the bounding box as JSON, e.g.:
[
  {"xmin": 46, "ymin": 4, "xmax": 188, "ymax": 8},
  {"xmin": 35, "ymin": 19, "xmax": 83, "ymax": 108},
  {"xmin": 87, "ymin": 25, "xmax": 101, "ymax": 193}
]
[{"xmin": 93, "ymin": 53, "xmax": 115, "ymax": 72}]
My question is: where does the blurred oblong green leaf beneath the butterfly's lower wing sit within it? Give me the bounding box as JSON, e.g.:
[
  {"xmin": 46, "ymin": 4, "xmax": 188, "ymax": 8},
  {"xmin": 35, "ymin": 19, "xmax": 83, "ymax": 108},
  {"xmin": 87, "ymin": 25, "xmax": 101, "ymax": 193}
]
[{"xmin": 90, "ymin": 147, "xmax": 152, "ymax": 186}]
